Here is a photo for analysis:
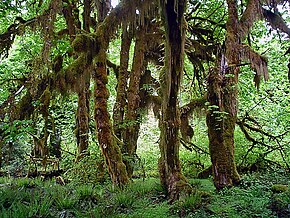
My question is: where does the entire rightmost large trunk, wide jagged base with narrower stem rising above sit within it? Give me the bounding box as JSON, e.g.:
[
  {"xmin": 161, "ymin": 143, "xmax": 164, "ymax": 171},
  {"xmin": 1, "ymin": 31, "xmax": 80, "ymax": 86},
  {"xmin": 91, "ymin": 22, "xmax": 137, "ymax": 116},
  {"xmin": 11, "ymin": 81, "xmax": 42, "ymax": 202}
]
[{"xmin": 207, "ymin": 0, "xmax": 240, "ymax": 189}]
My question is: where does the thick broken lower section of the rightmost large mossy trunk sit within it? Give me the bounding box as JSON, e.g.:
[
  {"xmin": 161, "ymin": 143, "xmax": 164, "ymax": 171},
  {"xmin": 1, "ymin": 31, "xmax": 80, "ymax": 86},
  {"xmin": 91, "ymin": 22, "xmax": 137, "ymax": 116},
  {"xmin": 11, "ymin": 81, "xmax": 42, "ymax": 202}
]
[{"xmin": 207, "ymin": 70, "xmax": 240, "ymax": 190}]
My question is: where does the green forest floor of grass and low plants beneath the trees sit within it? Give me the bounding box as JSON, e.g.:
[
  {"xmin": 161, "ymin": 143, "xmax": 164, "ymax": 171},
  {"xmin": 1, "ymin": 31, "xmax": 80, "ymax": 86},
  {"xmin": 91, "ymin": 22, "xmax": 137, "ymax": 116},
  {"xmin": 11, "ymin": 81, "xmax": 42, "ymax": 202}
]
[{"xmin": 0, "ymin": 171, "xmax": 290, "ymax": 218}]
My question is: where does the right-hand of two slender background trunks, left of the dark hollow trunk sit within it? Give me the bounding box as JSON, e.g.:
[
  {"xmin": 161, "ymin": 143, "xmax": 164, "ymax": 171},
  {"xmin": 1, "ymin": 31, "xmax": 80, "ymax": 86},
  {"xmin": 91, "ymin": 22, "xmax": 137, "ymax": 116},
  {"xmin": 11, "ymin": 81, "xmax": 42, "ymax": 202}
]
[{"xmin": 124, "ymin": 26, "xmax": 145, "ymax": 177}]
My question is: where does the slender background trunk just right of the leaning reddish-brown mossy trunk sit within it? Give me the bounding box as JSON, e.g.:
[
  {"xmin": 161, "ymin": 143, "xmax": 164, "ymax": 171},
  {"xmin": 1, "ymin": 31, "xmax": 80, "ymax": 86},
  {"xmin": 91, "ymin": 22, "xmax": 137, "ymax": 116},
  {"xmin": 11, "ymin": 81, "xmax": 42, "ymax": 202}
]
[{"xmin": 113, "ymin": 26, "xmax": 132, "ymax": 140}]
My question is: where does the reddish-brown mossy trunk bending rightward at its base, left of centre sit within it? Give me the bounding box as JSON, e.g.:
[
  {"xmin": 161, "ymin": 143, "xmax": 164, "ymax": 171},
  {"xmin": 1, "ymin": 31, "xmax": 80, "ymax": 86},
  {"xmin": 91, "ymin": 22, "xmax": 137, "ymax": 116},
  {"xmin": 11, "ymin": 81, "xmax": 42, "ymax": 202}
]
[{"xmin": 94, "ymin": 0, "xmax": 129, "ymax": 186}]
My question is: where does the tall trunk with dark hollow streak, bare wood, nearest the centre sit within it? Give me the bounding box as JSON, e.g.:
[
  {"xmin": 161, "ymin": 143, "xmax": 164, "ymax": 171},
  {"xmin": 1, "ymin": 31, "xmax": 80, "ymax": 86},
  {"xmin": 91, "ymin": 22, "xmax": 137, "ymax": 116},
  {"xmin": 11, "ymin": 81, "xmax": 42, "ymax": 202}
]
[{"xmin": 158, "ymin": 0, "xmax": 187, "ymax": 200}]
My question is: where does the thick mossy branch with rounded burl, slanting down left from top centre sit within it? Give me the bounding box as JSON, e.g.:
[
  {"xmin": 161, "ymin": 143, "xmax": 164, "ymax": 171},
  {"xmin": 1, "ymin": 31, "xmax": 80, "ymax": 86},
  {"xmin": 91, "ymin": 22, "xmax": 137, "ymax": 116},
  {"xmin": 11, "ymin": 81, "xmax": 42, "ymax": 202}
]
[{"xmin": 62, "ymin": 0, "xmax": 154, "ymax": 90}]
